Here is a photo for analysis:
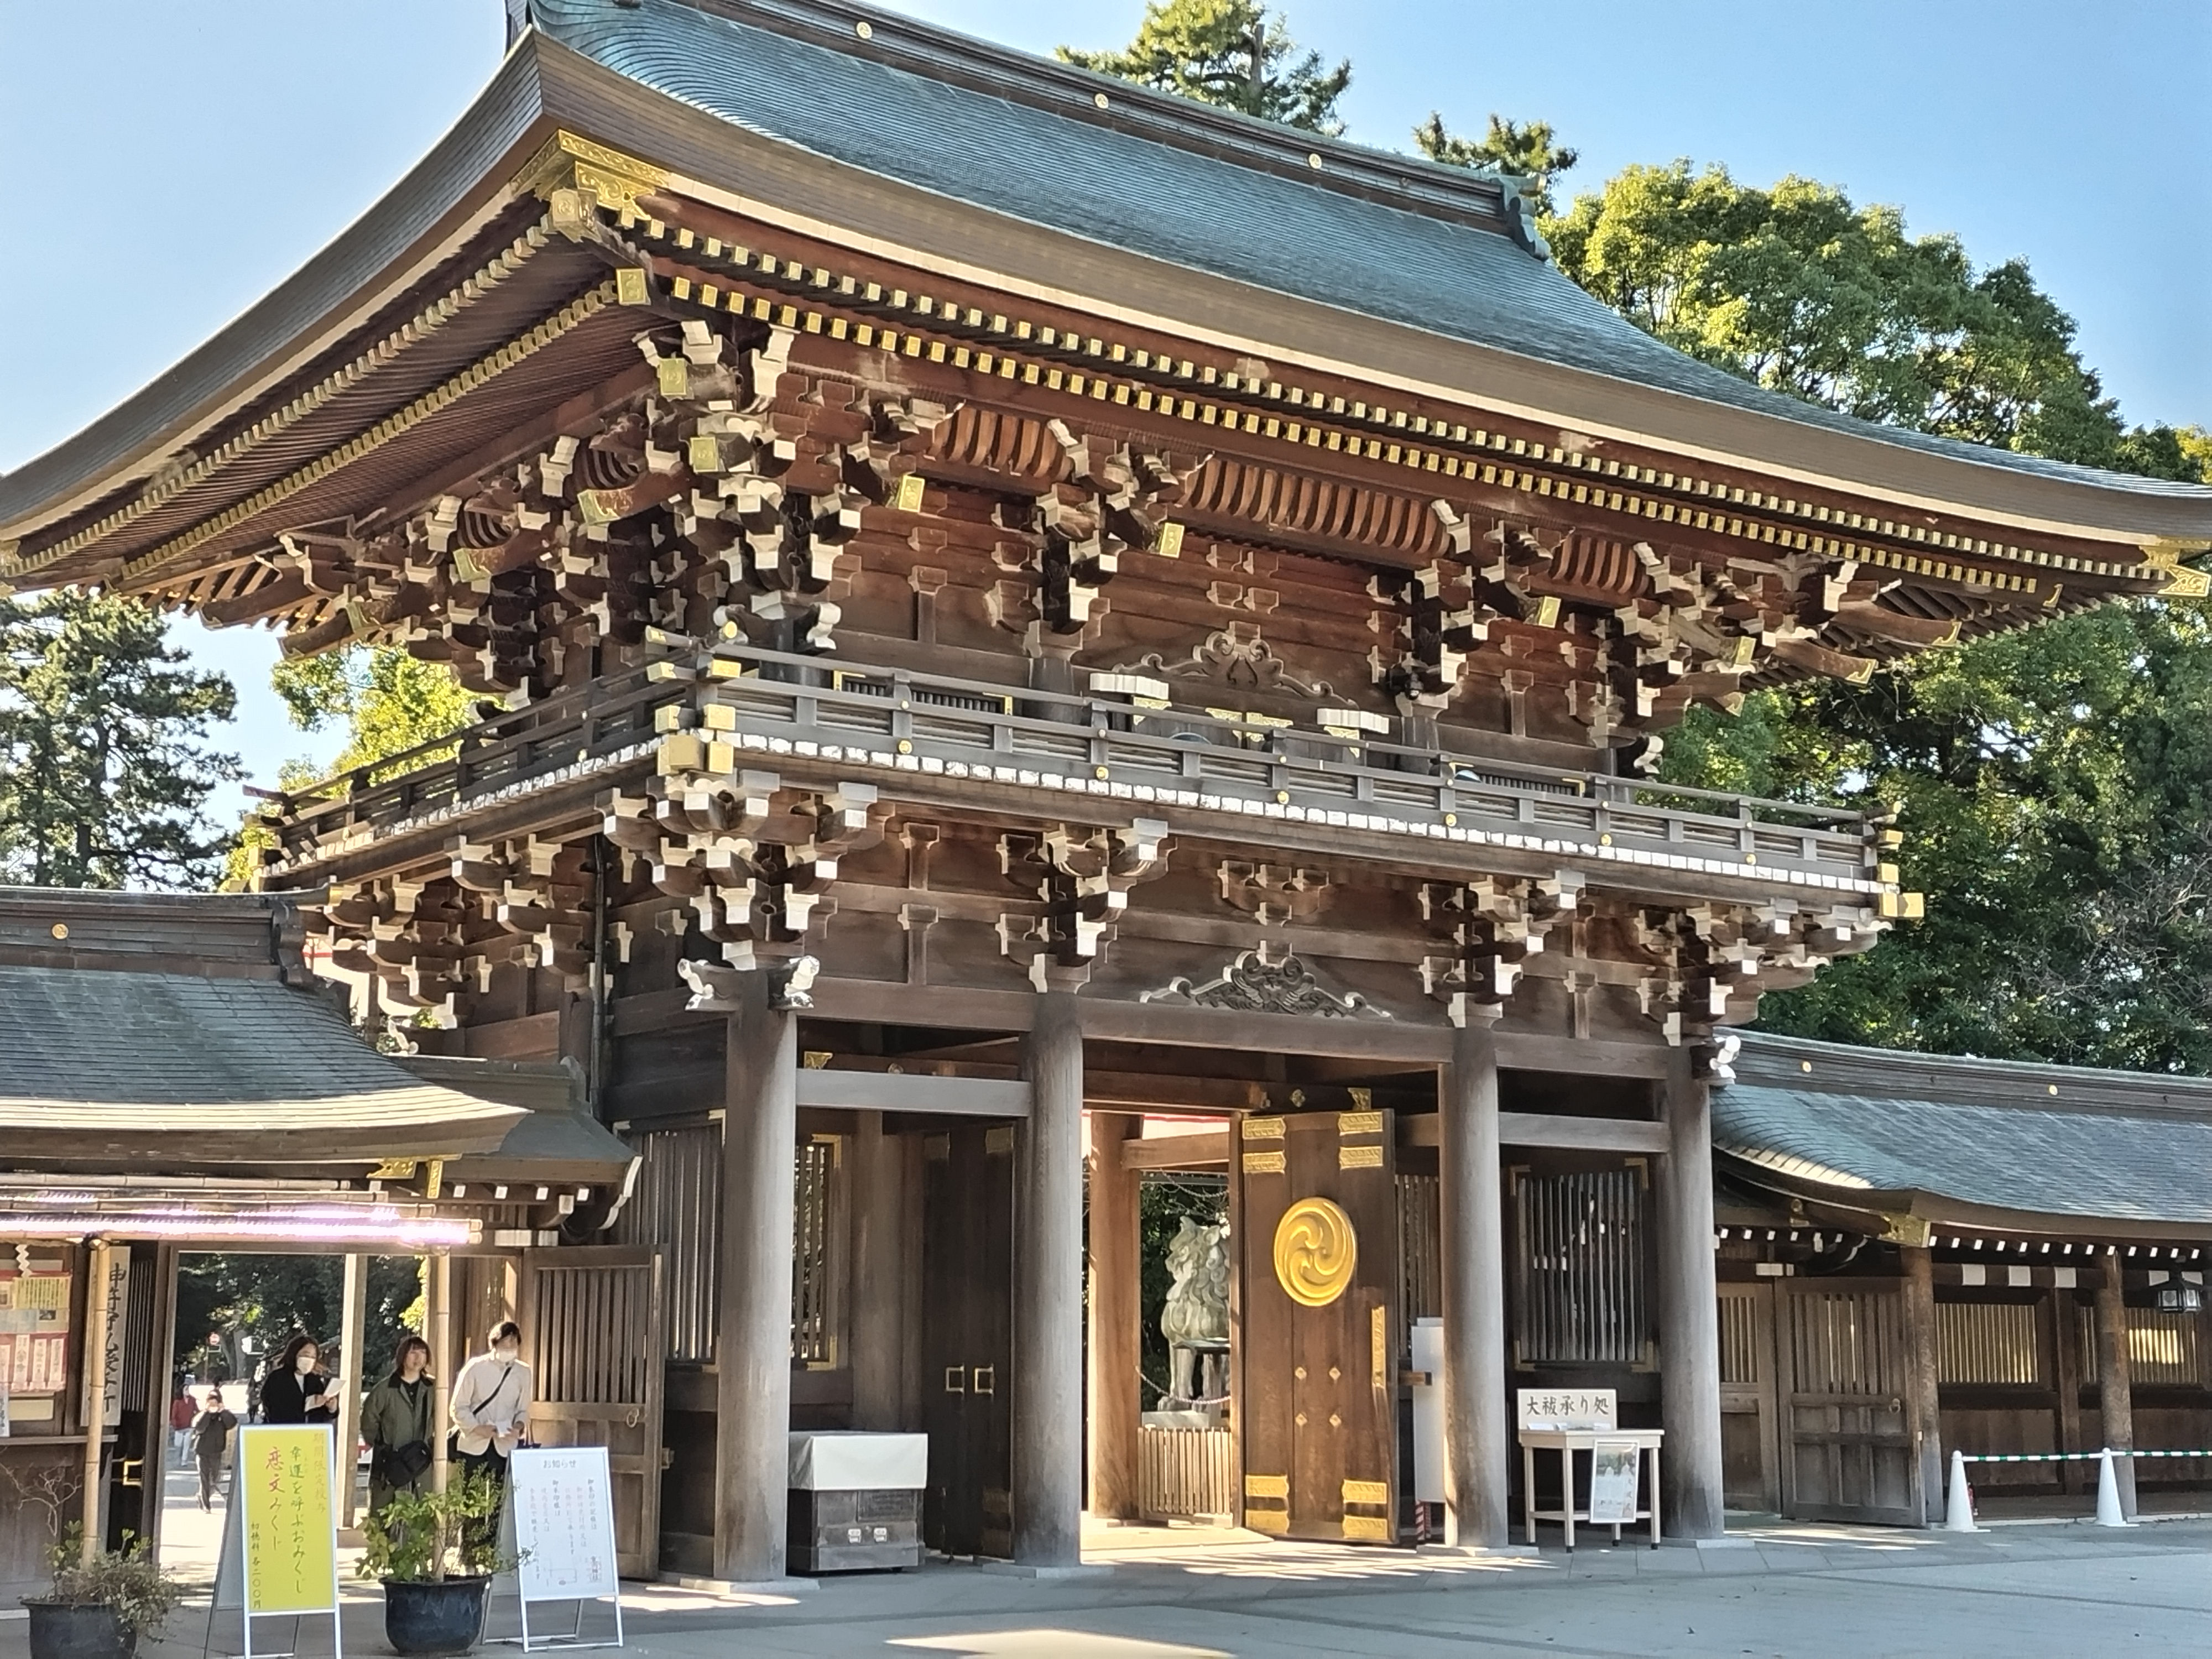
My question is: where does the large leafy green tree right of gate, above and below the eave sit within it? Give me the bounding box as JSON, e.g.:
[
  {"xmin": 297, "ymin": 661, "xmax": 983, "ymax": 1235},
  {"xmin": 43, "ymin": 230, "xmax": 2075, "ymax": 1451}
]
[{"xmin": 1544, "ymin": 161, "xmax": 2212, "ymax": 1071}]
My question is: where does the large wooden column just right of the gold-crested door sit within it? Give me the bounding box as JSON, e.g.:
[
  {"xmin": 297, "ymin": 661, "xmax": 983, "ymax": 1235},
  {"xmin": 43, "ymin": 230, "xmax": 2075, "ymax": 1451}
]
[{"xmin": 1438, "ymin": 1015, "xmax": 1509, "ymax": 1548}]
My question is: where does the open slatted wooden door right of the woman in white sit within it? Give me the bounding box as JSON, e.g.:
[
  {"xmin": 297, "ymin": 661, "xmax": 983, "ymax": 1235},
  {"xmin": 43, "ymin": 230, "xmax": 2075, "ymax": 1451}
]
[{"xmin": 518, "ymin": 1245, "xmax": 666, "ymax": 1579}]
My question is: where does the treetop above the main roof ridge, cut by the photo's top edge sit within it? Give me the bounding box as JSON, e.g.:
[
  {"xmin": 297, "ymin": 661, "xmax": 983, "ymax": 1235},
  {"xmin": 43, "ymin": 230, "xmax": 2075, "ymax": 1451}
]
[{"xmin": 1057, "ymin": 0, "xmax": 1352, "ymax": 137}]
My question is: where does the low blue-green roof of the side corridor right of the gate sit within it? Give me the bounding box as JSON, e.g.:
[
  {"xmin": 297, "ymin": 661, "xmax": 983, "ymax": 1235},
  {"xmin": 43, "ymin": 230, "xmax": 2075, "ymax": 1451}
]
[{"xmin": 1712, "ymin": 1037, "xmax": 2212, "ymax": 1223}]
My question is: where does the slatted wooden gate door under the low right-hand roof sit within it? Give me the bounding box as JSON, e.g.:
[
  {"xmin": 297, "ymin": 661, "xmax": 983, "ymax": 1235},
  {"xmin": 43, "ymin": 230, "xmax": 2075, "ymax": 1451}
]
[{"xmin": 1778, "ymin": 1279, "xmax": 1922, "ymax": 1526}]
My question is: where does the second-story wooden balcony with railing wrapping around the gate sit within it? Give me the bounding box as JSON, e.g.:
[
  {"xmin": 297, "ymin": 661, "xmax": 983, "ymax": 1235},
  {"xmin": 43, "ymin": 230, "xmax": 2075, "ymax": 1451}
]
[{"xmin": 263, "ymin": 646, "xmax": 1918, "ymax": 916}]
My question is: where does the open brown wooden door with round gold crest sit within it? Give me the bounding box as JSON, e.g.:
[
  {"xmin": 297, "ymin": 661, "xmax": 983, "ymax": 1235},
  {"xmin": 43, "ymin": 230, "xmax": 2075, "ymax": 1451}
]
[{"xmin": 1232, "ymin": 1113, "xmax": 1398, "ymax": 1544}]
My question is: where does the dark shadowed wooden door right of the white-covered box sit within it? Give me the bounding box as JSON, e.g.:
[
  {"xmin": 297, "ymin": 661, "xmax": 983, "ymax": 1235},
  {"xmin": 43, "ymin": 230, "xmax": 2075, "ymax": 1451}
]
[{"xmin": 922, "ymin": 1124, "xmax": 1020, "ymax": 1557}]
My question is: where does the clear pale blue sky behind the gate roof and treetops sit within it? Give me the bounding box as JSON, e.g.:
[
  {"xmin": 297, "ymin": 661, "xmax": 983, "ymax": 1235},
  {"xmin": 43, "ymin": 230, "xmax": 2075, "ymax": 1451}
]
[{"xmin": 0, "ymin": 0, "xmax": 2212, "ymax": 814}]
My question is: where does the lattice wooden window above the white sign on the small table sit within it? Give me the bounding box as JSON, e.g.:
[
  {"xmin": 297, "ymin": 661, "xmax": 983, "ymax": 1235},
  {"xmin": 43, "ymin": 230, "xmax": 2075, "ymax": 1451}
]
[{"xmin": 1513, "ymin": 1168, "xmax": 1650, "ymax": 1365}]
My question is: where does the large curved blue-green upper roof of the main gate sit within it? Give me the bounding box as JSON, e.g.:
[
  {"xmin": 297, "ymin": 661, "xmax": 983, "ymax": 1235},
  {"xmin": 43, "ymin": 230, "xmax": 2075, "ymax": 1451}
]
[{"xmin": 531, "ymin": 0, "xmax": 2212, "ymax": 513}]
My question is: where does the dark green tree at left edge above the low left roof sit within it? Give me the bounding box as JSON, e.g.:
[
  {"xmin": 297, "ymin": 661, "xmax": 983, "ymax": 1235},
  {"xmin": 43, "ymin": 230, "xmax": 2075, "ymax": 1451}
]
[{"xmin": 0, "ymin": 588, "xmax": 241, "ymax": 887}]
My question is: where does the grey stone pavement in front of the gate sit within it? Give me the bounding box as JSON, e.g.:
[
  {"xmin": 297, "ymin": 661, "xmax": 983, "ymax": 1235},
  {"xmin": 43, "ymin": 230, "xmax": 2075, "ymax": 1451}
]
[{"xmin": 22, "ymin": 1522, "xmax": 2212, "ymax": 1659}]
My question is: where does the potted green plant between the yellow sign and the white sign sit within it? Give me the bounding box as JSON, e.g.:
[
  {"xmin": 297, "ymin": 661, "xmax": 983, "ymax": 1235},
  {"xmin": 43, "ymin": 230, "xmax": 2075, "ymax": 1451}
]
[{"xmin": 354, "ymin": 1471, "xmax": 520, "ymax": 1657}]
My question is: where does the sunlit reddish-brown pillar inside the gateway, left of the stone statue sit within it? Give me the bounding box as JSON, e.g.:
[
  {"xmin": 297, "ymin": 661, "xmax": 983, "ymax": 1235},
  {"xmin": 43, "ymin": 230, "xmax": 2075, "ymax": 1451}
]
[{"xmin": 1091, "ymin": 1113, "xmax": 1144, "ymax": 1520}]
